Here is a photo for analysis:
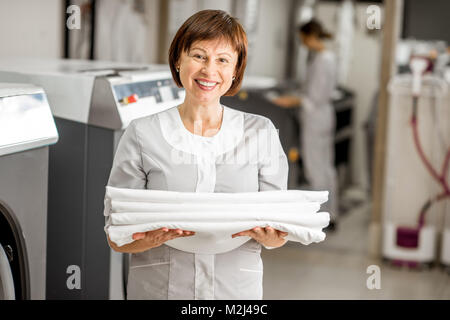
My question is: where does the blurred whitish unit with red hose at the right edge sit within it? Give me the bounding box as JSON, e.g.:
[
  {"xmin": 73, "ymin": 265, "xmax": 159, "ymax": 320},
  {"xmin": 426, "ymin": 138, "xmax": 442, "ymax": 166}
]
[{"xmin": 382, "ymin": 74, "xmax": 450, "ymax": 267}]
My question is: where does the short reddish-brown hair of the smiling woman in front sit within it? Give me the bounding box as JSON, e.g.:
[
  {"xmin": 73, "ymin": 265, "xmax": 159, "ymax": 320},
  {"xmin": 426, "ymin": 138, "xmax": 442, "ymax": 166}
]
[{"xmin": 169, "ymin": 10, "xmax": 248, "ymax": 96}]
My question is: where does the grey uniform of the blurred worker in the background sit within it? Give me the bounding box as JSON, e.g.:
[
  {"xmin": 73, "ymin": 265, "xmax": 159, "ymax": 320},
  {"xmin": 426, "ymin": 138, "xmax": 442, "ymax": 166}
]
[{"xmin": 300, "ymin": 50, "xmax": 339, "ymax": 219}]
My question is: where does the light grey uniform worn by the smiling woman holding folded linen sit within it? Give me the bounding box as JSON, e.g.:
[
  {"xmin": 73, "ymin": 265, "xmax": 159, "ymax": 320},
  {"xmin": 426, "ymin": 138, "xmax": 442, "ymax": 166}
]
[{"xmin": 106, "ymin": 106, "xmax": 288, "ymax": 299}]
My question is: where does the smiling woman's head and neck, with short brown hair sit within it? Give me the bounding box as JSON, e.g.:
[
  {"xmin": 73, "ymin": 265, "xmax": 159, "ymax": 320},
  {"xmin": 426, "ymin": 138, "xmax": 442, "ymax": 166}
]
[{"xmin": 169, "ymin": 10, "xmax": 248, "ymax": 137}]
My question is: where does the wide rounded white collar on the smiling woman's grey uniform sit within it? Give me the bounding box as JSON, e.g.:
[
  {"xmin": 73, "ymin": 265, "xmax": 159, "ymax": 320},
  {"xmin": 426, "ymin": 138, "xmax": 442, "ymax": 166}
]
[{"xmin": 158, "ymin": 105, "xmax": 244, "ymax": 156}]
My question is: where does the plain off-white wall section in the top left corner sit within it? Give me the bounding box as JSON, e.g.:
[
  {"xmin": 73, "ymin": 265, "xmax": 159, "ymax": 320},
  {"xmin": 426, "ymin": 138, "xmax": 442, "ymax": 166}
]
[{"xmin": 0, "ymin": 0, "xmax": 65, "ymax": 58}]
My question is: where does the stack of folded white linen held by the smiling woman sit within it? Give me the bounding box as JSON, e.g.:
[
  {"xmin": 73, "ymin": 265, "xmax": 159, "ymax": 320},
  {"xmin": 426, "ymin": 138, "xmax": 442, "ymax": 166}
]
[{"xmin": 104, "ymin": 187, "xmax": 330, "ymax": 254}]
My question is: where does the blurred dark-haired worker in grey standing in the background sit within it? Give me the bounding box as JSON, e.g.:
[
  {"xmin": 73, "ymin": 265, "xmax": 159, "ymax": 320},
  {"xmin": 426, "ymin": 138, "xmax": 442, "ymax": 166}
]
[{"xmin": 274, "ymin": 20, "xmax": 339, "ymax": 230}]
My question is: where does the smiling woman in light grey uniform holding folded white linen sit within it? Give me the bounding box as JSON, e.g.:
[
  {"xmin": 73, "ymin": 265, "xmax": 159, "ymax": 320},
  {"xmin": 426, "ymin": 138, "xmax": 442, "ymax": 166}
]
[{"xmin": 106, "ymin": 10, "xmax": 288, "ymax": 299}]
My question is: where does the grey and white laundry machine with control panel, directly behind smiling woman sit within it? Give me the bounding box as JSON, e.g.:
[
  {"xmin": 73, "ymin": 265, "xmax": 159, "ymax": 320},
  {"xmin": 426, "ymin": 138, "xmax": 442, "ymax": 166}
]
[{"xmin": 0, "ymin": 59, "xmax": 184, "ymax": 299}]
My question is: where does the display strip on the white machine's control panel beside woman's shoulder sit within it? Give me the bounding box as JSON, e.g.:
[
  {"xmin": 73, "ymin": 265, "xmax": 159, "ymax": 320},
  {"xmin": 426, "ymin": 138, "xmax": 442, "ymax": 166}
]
[{"xmin": 114, "ymin": 79, "xmax": 182, "ymax": 103}]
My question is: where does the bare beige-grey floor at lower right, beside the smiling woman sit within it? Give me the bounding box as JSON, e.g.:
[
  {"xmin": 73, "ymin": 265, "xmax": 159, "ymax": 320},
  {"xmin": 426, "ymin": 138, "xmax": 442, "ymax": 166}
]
[{"xmin": 262, "ymin": 200, "xmax": 450, "ymax": 300}]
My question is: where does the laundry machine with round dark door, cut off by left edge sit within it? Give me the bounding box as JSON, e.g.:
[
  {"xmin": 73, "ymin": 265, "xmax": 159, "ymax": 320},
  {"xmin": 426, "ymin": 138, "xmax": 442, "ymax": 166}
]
[{"xmin": 0, "ymin": 83, "xmax": 58, "ymax": 300}]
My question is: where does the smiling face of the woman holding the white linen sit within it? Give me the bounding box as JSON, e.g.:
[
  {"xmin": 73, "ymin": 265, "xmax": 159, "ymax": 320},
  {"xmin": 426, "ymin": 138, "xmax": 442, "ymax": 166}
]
[{"xmin": 177, "ymin": 40, "xmax": 237, "ymax": 104}]
